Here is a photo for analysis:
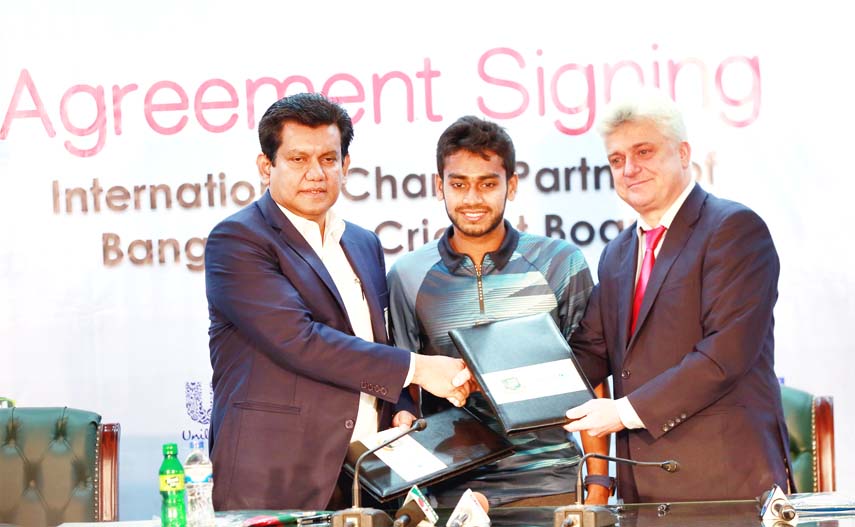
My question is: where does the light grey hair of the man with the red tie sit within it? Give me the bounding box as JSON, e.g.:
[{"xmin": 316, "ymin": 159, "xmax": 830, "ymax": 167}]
[{"xmin": 597, "ymin": 89, "xmax": 689, "ymax": 142}]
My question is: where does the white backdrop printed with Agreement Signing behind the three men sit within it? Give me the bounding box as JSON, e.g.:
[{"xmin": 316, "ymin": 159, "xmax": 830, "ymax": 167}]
[{"xmin": 0, "ymin": 0, "xmax": 855, "ymax": 519}]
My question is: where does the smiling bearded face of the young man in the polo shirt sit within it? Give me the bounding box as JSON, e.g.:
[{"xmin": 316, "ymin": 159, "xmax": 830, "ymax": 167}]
[{"xmin": 436, "ymin": 150, "xmax": 517, "ymax": 243}]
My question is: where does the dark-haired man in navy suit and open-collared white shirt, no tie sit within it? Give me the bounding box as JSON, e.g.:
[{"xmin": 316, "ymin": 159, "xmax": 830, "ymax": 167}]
[{"xmin": 205, "ymin": 93, "xmax": 470, "ymax": 510}]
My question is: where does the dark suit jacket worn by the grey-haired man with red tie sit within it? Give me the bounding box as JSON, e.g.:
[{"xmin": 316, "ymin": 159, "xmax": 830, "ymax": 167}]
[{"xmin": 571, "ymin": 186, "xmax": 789, "ymax": 502}]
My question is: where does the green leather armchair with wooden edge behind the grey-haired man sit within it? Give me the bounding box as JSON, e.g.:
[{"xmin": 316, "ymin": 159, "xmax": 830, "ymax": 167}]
[{"xmin": 781, "ymin": 386, "xmax": 837, "ymax": 492}]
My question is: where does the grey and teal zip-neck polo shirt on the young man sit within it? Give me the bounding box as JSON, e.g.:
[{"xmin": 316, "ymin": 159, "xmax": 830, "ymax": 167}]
[{"xmin": 388, "ymin": 221, "xmax": 593, "ymax": 506}]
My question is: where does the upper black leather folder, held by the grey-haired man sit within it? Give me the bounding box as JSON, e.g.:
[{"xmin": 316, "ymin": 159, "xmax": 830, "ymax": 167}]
[{"xmin": 448, "ymin": 313, "xmax": 594, "ymax": 434}]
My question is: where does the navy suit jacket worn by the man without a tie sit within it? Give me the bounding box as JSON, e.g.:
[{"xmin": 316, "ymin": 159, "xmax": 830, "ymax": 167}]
[{"xmin": 205, "ymin": 192, "xmax": 410, "ymax": 510}]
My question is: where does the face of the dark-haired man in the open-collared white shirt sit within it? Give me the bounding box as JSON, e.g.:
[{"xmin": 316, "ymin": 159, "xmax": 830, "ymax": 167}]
[{"xmin": 257, "ymin": 121, "xmax": 350, "ymax": 228}]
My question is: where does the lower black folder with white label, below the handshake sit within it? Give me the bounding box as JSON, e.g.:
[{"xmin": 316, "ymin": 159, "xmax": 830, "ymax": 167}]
[{"xmin": 344, "ymin": 407, "xmax": 513, "ymax": 502}]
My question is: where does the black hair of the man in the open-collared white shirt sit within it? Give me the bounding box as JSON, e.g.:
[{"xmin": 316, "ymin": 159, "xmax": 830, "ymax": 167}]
[{"xmin": 258, "ymin": 93, "xmax": 353, "ymax": 165}]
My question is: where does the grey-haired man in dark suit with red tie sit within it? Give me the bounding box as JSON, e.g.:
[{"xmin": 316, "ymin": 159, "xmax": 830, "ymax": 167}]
[{"xmin": 565, "ymin": 89, "xmax": 792, "ymax": 502}]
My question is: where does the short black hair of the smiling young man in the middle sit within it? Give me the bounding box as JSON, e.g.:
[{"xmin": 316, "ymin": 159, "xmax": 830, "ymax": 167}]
[{"xmin": 436, "ymin": 115, "xmax": 517, "ymax": 178}]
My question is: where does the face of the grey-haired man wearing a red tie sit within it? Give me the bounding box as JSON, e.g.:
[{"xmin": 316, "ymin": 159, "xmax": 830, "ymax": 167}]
[{"xmin": 605, "ymin": 120, "xmax": 691, "ymax": 226}]
